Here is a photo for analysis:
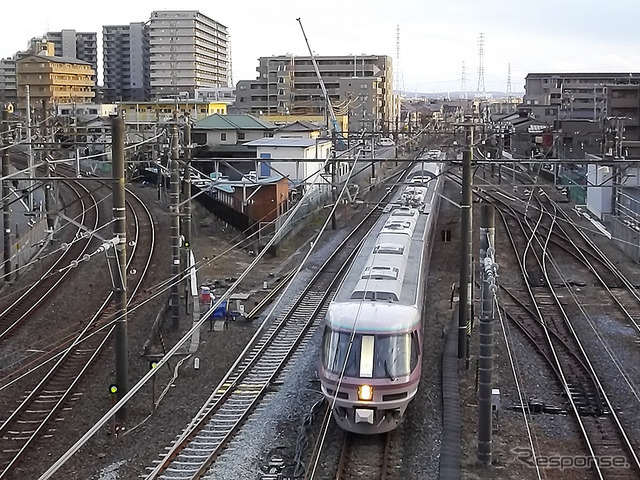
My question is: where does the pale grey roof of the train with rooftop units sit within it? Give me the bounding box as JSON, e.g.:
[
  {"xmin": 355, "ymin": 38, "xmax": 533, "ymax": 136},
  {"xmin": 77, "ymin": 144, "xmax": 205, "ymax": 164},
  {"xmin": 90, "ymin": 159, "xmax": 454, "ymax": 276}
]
[{"xmin": 326, "ymin": 164, "xmax": 441, "ymax": 331}]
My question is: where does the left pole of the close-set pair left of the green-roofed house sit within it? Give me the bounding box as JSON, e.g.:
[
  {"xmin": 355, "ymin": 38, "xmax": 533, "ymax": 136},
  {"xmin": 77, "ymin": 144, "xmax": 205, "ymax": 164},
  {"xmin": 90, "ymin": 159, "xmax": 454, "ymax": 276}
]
[{"xmin": 169, "ymin": 124, "xmax": 180, "ymax": 330}]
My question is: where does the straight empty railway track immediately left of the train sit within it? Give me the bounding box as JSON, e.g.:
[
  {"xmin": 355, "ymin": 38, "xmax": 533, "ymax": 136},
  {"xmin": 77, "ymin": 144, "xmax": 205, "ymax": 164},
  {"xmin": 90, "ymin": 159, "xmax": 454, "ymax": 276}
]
[{"xmin": 145, "ymin": 162, "xmax": 418, "ymax": 480}]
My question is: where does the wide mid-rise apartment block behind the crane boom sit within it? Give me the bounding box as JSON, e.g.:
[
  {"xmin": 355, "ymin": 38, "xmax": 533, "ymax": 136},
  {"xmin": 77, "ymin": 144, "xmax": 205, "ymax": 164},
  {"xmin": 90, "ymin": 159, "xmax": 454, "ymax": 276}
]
[{"xmin": 233, "ymin": 55, "xmax": 395, "ymax": 132}]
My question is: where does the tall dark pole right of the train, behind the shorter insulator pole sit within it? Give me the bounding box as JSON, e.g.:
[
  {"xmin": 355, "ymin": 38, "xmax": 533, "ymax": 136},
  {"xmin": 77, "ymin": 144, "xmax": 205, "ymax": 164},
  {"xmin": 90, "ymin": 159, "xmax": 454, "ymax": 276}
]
[{"xmin": 458, "ymin": 124, "xmax": 473, "ymax": 359}]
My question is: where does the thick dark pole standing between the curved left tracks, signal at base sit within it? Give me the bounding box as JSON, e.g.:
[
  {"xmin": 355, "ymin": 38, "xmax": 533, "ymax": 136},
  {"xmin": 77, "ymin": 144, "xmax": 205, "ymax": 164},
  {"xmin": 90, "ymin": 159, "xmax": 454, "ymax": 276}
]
[{"xmin": 111, "ymin": 116, "xmax": 129, "ymax": 424}]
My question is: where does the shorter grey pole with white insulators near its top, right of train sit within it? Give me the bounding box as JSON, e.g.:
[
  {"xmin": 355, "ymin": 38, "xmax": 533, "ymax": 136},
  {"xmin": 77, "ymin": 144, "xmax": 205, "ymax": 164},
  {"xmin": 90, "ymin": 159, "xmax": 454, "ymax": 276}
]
[{"xmin": 478, "ymin": 204, "xmax": 498, "ymax": 465}]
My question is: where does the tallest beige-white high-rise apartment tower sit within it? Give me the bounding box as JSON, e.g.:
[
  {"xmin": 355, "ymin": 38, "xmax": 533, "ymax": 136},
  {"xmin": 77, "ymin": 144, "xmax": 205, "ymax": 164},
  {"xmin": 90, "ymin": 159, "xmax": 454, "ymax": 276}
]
[{"xmin": 149, "ymin": 11, "xmax": 229, "ymax": 99}]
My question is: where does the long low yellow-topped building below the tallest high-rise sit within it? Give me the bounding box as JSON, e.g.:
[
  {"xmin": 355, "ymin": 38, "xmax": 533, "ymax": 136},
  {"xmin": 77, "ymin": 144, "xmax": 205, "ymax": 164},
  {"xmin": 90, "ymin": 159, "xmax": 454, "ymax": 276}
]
[{"xmin": 116, "ymin": 98, "xmax": 227, "ymax": 124}]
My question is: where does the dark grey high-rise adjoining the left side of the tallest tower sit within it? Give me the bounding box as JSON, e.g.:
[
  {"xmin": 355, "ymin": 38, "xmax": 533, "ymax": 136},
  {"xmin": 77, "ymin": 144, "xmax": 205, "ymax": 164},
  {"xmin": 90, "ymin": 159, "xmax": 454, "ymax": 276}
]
[{"xmin": 102, "ymin": 22, "xmax": 150, "ymax": 102}]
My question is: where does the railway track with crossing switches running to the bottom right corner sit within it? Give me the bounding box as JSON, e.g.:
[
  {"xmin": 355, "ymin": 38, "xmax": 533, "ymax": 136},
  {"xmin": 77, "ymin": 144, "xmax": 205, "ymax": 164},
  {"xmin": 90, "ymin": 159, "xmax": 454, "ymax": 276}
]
[{"xmin": 482, "ymin": 179, "xmax": 640, "ymax": 479}]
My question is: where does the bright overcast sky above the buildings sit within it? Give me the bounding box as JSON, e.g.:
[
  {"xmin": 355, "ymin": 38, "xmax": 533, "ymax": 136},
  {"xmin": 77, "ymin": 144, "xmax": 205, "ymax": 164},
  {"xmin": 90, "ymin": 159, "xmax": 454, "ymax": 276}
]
[{"xmin": 0, "ymin": 0, "xmax": 640, "ymax": 93}]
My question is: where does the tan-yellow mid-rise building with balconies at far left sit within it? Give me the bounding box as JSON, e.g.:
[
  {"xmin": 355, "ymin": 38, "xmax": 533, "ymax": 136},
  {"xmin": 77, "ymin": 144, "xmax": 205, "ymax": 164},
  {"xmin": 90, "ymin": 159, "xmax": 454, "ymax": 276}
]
[{"xmin": 16, "ymin": 54, "xmax": 95, "ymax": 113}]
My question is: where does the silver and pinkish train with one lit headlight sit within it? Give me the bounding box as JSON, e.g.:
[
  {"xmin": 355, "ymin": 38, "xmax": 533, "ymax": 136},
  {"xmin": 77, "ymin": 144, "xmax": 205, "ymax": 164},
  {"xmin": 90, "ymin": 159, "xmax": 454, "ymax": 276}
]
[{"xmin": 319, "ymin": 162, "xmax": 440, "ymax": 434}]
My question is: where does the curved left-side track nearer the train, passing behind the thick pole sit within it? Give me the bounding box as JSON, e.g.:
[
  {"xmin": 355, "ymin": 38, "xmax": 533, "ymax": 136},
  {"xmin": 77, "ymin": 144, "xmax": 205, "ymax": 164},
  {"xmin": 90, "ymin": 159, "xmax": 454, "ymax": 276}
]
[{"xmin": 0, "ymin": 186, "xmax": 155, "ymax": 479}]
